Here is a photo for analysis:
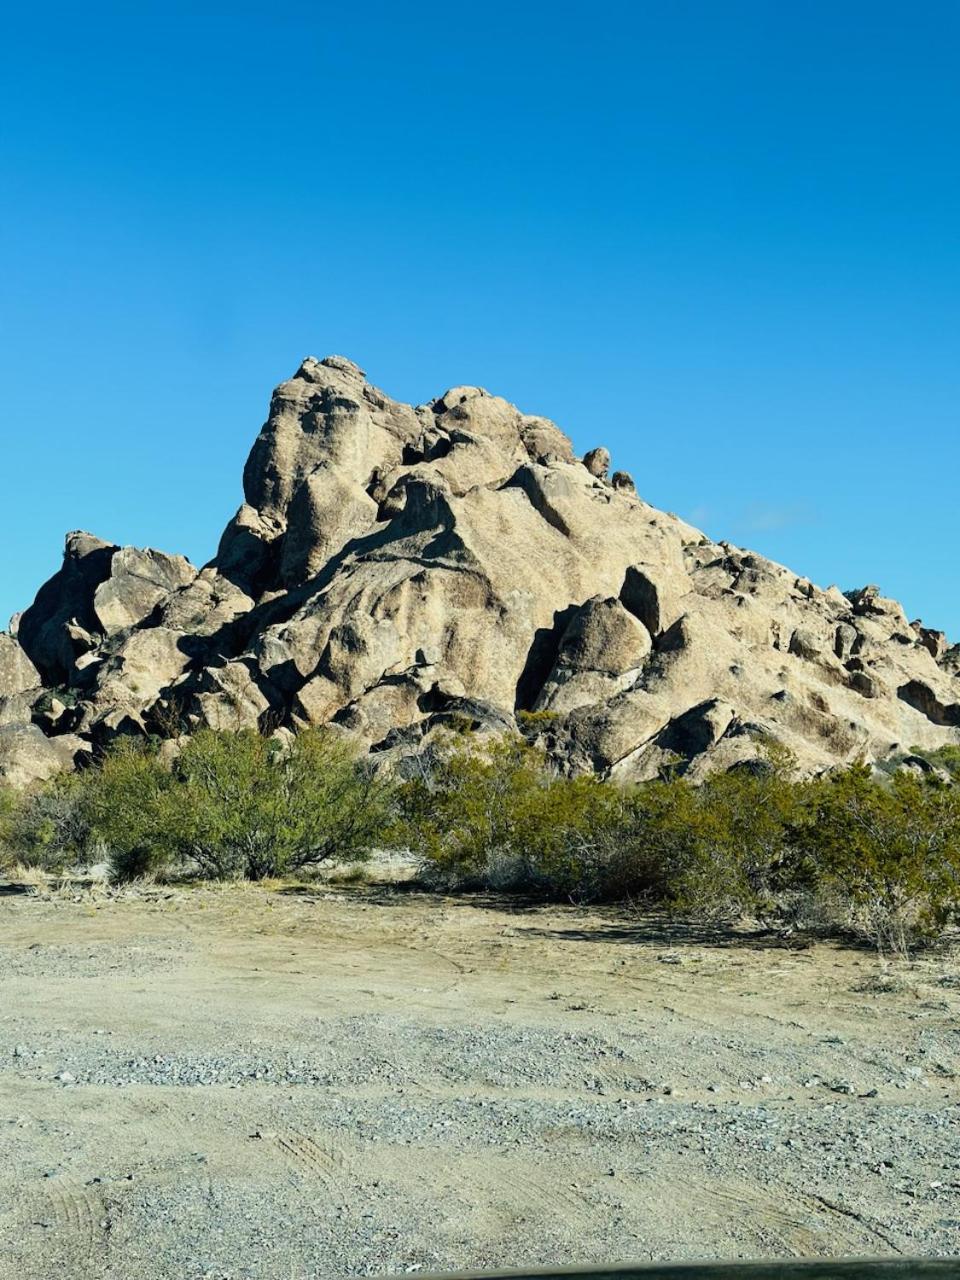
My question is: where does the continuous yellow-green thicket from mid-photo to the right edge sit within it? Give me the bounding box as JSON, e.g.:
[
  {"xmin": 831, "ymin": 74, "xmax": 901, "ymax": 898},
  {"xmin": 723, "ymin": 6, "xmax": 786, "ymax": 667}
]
[{"xmin": 401, "ymin": 735, "xmax": 960, "ymax": 952}]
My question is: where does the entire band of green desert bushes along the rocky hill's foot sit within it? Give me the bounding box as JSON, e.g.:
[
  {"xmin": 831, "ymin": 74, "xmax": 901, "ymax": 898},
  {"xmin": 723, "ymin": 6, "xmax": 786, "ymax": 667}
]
[{"xmin": 0, "ymin": 730, "xmax": 960, "ymax": 954}]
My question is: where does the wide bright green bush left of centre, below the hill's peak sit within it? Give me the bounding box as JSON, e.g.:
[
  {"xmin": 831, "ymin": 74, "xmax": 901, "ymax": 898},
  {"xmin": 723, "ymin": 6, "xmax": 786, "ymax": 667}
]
[{"xmin": 87, "ymin": 730, "xmax": 393, "ymax": 879}]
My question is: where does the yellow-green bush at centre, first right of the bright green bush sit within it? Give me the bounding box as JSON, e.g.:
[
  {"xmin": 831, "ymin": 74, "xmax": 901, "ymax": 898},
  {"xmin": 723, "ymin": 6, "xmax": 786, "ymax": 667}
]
[{"xmin": 399, "ymin": 736, "xmax": 622, "ymax": 895}]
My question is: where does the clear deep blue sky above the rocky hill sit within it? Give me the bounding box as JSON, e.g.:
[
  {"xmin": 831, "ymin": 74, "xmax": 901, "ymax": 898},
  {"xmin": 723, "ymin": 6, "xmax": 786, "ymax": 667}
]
[{"xmin": 0, "ymin": 0, "xmax": 960, "ymax": 639}]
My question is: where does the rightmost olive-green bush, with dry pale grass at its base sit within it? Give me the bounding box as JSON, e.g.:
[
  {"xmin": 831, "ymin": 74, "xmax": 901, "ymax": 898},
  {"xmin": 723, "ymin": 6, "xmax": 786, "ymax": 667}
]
[{"xmin": 801, "ymin": 764, "xmax": 960, "ymax": 954}]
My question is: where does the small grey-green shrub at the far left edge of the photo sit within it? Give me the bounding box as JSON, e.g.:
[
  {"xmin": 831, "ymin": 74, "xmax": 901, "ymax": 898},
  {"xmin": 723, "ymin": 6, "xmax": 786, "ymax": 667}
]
[{"xmin": 0, "ymin": 773, "xmax": 96, "ymax": 872}]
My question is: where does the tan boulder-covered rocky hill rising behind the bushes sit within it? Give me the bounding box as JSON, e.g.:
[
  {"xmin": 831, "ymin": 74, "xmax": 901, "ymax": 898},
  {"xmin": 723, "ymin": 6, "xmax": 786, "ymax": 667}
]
[{"xmin": 0, "ymin": 356, "xmax": 960, "ymax": 786}]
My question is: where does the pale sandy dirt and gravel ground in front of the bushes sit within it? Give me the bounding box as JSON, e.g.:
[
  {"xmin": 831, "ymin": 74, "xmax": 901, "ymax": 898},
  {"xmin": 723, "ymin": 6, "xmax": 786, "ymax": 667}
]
[{"xmin": 0, "ymin": 883, "xmax": 960, "ymax": 1280}]
